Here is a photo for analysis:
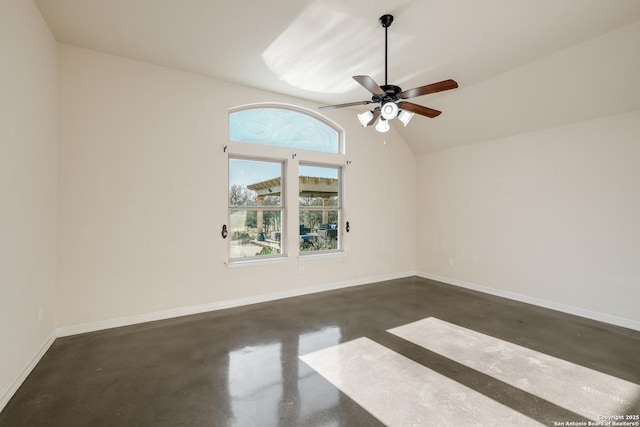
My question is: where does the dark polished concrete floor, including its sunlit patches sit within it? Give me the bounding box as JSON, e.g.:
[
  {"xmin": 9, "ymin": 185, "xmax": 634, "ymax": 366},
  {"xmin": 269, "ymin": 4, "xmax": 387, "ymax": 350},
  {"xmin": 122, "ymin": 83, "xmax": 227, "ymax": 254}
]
[{"xmin": 0, "ymin": 277, "xmax": 640, "ymax": 427}]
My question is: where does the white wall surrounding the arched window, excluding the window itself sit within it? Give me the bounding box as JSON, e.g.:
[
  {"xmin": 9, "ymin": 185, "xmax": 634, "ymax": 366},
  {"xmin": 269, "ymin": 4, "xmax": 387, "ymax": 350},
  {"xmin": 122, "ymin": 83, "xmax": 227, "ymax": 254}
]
[{"xmin": 57, "ymin": 44, "xmax": 416, "ymax": 327}]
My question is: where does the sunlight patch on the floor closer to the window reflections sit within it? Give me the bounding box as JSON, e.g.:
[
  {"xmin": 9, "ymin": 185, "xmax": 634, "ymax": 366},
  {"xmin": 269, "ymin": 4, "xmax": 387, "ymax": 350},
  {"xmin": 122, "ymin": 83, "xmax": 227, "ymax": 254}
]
[{"xmin": 300, "ymin": 338, "xmax": 542, "ymax": 427}]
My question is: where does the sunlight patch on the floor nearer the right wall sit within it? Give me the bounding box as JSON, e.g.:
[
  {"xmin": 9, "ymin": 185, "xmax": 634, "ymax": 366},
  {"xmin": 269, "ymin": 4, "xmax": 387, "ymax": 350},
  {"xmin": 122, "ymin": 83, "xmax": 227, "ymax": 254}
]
[{"xmin": 388, "ymin": 317, "xmax": 640, "ymax": 421}]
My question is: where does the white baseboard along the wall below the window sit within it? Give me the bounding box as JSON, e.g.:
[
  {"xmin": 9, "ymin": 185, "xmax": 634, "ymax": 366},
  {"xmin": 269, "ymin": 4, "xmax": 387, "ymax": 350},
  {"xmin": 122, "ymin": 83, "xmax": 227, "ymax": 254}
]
[{"xmin": 56, "ymin": 271, "xmax": 416, "ymax": 337}]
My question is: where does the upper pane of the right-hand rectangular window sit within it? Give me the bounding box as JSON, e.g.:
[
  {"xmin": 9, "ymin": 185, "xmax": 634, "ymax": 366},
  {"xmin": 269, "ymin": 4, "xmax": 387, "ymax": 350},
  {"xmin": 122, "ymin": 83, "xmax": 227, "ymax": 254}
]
[{"xmin": 298, "ymin": 165, "xmax": 340, "ymax": 207}]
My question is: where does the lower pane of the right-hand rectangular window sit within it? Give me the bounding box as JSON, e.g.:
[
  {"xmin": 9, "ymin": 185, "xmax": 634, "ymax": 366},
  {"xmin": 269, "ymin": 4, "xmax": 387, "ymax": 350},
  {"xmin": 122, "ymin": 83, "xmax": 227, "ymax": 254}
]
[{"xmin": 300, "ymin": 210, "xmax": 340, "ymax": 251}]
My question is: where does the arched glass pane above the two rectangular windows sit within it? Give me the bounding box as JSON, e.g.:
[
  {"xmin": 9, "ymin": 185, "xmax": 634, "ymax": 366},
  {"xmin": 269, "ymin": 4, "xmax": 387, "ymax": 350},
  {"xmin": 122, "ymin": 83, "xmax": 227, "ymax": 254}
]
[{"xmin": 229, "ymin": 108, "xmax": 340, "ymax": 153}]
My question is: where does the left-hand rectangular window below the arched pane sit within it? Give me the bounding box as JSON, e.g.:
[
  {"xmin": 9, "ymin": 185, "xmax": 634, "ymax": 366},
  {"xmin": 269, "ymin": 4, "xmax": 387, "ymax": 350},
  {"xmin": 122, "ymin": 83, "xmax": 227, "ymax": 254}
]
[{"xmin": 229, "ymin": 157, "xmax": 286, "ymax": 260}]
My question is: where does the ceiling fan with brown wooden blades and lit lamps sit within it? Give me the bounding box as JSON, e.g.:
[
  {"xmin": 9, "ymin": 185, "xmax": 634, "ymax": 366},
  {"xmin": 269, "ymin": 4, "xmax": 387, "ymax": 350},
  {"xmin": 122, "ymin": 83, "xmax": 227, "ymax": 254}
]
[{"xmin": 320, "ymin": 15, "xmax": 458, "ymax": 132}]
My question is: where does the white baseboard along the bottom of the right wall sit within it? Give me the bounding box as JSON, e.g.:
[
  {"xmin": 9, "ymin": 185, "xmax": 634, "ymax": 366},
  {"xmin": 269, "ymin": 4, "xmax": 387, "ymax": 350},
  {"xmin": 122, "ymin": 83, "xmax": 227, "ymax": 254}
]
[{"xmin": 416, "ymin": 272, "xmax": 640, "ymax": 331}]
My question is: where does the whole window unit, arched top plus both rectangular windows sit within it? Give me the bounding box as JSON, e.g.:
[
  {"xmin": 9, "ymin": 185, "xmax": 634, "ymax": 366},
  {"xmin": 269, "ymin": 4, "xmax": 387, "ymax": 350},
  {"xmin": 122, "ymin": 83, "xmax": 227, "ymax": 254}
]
[{"xmin": 228, "ymin": 104, "xmax": 344, "ymax": 265}]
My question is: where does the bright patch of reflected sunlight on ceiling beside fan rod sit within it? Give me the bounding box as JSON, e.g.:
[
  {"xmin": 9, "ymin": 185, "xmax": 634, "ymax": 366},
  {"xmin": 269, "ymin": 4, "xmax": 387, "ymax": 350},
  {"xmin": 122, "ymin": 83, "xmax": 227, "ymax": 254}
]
[{"xmin": 262, "ymin": 0, "xmax": 410, "ymax": 93}]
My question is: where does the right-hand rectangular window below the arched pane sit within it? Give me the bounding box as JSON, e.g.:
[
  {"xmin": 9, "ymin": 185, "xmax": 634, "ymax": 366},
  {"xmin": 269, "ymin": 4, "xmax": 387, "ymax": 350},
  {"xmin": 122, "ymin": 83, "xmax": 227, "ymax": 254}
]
[{"xmin": 298, "ymin": 163, "xmax": 342, "ymax": 255}]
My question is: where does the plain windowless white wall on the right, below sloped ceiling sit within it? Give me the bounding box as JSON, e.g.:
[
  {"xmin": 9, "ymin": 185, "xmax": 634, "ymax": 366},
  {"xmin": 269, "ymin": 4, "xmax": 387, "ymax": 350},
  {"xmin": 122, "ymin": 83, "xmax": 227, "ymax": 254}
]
[{"xmin": 416, "ymin": 111, "xmax": 640, "ymax": 327}]
